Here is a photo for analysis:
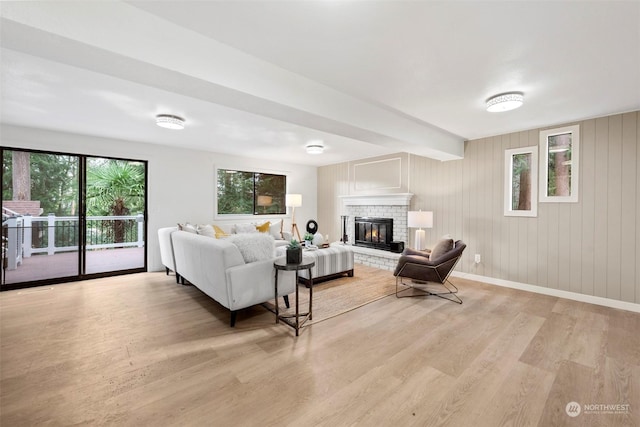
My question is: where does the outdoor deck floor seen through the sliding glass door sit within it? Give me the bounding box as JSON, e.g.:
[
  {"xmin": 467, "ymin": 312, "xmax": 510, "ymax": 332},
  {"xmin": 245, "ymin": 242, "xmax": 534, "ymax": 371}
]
[{"xmin": 2, "ymin": 247, "xmax": 144, "ymax": 285}]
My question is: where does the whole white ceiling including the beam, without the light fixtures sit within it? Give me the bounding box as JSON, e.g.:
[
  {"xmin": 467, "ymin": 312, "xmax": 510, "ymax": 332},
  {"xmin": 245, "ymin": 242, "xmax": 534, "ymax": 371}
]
[{"xmin": 0, "ymin": 0, "xmax": 640, "ymax": 165}]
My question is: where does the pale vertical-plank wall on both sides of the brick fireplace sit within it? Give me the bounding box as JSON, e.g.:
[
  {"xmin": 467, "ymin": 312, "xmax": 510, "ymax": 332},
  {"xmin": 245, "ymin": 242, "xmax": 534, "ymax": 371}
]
[{"xmin": 318, "ymin": 111, "xmax": 640, "ymax": 303}]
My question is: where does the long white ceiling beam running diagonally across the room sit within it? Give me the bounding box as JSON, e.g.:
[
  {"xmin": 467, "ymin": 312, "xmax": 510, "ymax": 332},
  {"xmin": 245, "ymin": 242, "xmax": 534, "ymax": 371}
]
[{"xmin": 0, "ymin": 2, "xmax": 464, "ymax": 160}]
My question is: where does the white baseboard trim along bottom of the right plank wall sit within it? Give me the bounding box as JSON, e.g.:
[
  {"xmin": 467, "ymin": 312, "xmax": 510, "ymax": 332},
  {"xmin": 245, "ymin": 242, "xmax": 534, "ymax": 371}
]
[{"xmin": 451, "ymin": 271, "xmax": 640, "ymax": 313}]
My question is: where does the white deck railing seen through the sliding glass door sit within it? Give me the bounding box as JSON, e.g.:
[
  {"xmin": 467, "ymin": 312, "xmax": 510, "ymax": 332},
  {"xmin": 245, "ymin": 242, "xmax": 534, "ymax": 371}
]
[{"xmin": 2, "ymin": 214, "xmax": 144, "ymax": 270}]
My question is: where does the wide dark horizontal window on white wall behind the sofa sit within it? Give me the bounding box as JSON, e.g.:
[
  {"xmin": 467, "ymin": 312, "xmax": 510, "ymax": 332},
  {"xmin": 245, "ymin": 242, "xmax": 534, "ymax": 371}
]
[{"xmin": 218, "ymin": 169, "xmax": 287, "ymax": 215}]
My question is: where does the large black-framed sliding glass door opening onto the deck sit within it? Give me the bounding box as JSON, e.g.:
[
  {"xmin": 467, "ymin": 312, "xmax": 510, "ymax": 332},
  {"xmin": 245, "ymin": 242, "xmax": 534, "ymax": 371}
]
[{"xmin": 0, "ymin": 148, "xmax": 146, "ymax": 290}]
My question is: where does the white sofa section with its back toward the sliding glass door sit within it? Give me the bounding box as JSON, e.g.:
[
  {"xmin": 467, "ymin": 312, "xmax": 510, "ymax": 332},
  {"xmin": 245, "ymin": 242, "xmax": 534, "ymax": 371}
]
[{"xmin": 158, "ymin": 227, "xmax": 295, "ymax": 327}]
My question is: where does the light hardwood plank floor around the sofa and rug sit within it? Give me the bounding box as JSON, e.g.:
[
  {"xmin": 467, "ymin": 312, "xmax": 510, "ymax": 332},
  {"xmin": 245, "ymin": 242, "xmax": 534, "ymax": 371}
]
[{"xmin": 0, "ymin": 265, "xmax": 640, "ymax": 426}]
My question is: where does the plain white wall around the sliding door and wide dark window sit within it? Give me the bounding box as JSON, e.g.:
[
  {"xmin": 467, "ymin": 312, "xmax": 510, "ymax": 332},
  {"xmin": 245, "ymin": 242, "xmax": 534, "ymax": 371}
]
[{"xmin": 0, "ymin": 125, "xmax": 317, "ymax": 271}]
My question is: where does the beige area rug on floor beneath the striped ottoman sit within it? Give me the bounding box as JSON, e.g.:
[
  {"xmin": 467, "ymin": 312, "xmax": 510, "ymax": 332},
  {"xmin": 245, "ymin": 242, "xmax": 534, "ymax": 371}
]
[{"xmin": 265, "ymin": 264, "xmax": 396, "ymax": 324}]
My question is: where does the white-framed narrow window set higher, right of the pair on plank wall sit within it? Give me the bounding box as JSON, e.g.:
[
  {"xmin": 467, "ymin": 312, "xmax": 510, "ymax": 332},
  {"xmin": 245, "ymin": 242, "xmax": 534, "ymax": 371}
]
[{"xmin": 540, "ymin": 126, "xmax": 580, "ymax": 202}]
